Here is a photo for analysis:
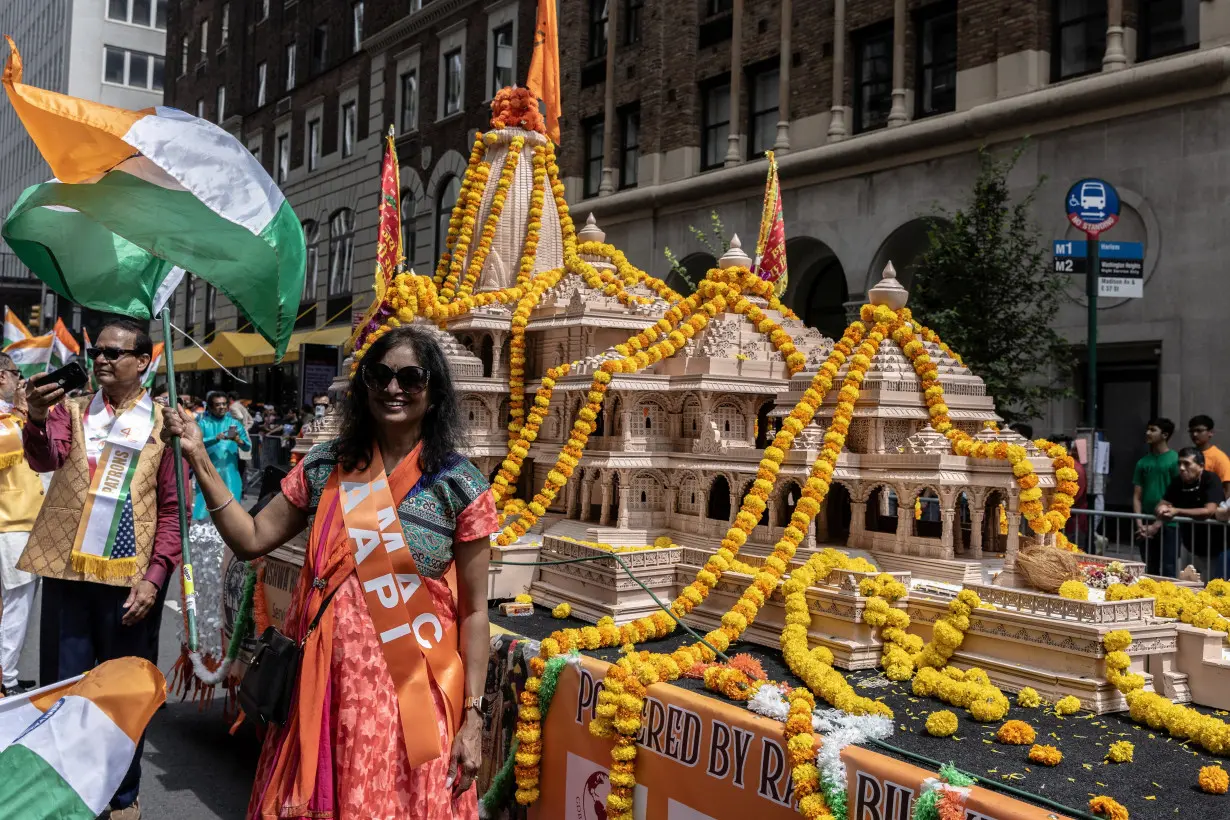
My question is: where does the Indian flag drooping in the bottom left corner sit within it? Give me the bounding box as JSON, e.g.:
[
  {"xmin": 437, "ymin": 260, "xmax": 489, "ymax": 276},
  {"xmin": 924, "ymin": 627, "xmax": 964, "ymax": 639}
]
[{"xmin": 0, "ymin": 658, "xmax": 166, "ymax": 820}]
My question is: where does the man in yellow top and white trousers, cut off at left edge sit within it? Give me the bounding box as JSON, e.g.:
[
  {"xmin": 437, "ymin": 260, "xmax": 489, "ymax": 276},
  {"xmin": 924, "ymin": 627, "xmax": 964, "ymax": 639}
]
[{"xmin": 0, "ymin": 353, "xmax": 43, "ymax": 695}]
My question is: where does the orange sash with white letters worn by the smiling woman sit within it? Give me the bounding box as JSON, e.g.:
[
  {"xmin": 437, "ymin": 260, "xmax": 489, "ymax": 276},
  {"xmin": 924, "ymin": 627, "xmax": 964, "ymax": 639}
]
[{"xmin": 326, "ymin": 447, "xmax": 465, "ymax": 766}]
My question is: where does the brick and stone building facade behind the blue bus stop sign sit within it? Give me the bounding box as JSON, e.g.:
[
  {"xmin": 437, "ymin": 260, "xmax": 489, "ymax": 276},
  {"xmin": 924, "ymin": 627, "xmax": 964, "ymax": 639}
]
[{"xmin": 561, "ymin": 0, "xmax": 1230, "ymax": 504}]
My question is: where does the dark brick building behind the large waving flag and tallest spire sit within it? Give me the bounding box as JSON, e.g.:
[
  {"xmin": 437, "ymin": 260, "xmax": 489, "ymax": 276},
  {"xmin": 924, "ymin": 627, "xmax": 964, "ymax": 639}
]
[{"xmin": 159, "ymin": 0, "xmax": 535, "ymax": 401}]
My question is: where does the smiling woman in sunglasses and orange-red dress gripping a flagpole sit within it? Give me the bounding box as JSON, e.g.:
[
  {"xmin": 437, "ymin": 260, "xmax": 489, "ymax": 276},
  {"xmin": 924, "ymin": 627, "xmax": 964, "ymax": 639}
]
[{"xmin": 165, "ymin": 327, "xmax": 496, "ymax": 820}]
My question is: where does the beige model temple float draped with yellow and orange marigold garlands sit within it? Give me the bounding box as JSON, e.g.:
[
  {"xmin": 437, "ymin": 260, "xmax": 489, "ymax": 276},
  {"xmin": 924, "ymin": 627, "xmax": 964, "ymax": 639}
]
[{"xmin": 216, "ymin": 89, "xmax": 1230, "ymax": 819}]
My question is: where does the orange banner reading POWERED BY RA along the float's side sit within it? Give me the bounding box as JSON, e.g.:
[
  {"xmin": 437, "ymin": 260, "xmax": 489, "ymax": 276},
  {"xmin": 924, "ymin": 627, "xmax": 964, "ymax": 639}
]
[{"xmin": 530, "ymin": 658, "xmax": 1064, "ymax": 820}]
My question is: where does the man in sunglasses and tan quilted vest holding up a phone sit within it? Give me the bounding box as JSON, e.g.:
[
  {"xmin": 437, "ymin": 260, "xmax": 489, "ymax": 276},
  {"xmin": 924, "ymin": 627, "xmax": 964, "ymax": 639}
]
[{"xmin": 18, "ymin": 317, "xmax": 187, "ymax": 820}]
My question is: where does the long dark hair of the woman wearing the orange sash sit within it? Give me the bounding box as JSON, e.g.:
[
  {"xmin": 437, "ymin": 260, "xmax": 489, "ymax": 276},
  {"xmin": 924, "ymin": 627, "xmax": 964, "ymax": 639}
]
[{"xmin": 337, "ymin": 325, "xmax": 465, "ymax": 473}]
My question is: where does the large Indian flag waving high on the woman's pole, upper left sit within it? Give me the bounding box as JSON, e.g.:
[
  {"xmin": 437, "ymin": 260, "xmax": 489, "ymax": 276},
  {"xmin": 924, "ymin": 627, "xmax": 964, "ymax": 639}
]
[{"xmin": 2, "ymin": 38, "xmax": 306, "ymax": 358}]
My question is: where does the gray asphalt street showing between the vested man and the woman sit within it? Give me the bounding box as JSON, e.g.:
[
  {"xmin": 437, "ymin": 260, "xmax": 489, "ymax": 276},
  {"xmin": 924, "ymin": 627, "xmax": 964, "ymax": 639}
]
[{"xmin": 20, "ymin": 575, "xmax": 260, "ymax": 820}]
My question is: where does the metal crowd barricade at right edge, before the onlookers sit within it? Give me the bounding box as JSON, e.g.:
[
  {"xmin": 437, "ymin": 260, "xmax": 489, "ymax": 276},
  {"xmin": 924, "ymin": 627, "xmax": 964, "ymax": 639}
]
[{"xmin": 1064, "ymin": 509, "xmax": 1230, "ymax": 581}]
